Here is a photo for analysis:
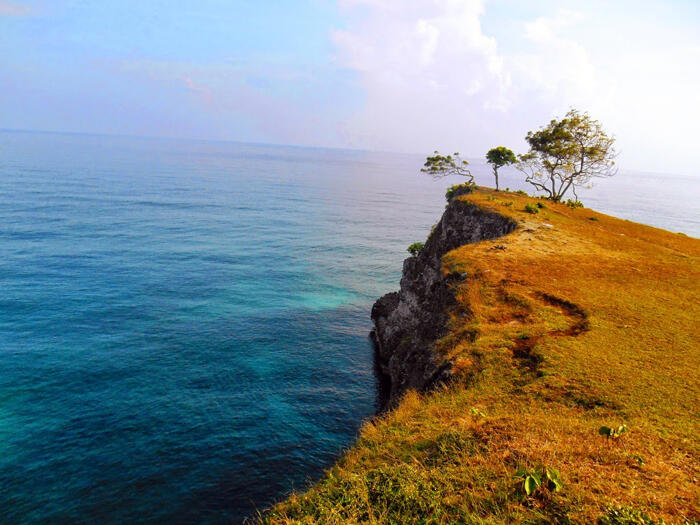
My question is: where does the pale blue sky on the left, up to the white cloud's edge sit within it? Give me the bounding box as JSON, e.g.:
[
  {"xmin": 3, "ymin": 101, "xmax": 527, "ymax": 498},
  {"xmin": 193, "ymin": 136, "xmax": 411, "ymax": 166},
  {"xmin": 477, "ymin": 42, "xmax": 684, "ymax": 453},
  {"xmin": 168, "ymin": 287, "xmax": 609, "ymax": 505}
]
[{"xmin": 0, "ymin": 0, "xmax": 361, "ymax": 143}]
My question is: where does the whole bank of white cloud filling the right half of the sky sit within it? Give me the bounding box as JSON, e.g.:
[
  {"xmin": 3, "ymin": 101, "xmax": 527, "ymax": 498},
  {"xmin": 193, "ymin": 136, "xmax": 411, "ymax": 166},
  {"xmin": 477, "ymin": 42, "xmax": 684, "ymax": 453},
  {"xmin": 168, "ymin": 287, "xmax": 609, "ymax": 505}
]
[{"xmin": 332, "ymin": 0, "xmax": 700, "ymax": 172}]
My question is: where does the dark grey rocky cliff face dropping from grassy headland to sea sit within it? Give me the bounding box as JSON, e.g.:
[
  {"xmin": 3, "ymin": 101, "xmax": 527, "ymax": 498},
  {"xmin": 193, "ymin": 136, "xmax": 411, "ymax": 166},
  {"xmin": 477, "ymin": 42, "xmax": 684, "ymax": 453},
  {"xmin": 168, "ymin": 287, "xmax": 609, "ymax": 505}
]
[{"xmin": 372, "ymin": 194, "xmax": 516, "ymax": 406}]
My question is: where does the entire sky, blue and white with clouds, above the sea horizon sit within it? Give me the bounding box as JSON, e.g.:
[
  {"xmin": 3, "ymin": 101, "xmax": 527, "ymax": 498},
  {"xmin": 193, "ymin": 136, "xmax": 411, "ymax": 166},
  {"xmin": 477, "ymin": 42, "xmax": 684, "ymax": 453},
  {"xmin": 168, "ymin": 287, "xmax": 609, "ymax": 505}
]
[{"xmin": 0, "ymin": 0, "xmax": 700, "ymax": 176}]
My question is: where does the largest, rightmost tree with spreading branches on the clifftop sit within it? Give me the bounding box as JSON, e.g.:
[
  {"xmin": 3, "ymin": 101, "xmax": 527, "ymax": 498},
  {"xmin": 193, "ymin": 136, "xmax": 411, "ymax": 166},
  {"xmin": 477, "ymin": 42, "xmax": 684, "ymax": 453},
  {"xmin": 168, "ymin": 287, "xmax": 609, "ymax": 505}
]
[{"xmin": 516, "ymin": 109, "xmax": 617, "ymax": 201}]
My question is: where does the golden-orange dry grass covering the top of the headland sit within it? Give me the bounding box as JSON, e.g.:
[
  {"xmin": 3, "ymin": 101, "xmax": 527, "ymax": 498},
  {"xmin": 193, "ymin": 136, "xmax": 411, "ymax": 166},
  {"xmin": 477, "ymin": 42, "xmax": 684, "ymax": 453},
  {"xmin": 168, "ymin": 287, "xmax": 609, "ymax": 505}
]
[{"xmin": 263, "ymin": 189, "xmax": 700, "ymax": 524}]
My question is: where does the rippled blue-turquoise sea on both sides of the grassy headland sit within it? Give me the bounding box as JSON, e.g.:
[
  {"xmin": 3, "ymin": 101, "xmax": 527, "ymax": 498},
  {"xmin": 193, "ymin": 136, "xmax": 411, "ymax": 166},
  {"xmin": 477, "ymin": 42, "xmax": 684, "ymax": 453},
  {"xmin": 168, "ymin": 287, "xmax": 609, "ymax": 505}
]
[{"xmin": 0, "ymin": 132, "xmax": 700, "ymax": 524}]
